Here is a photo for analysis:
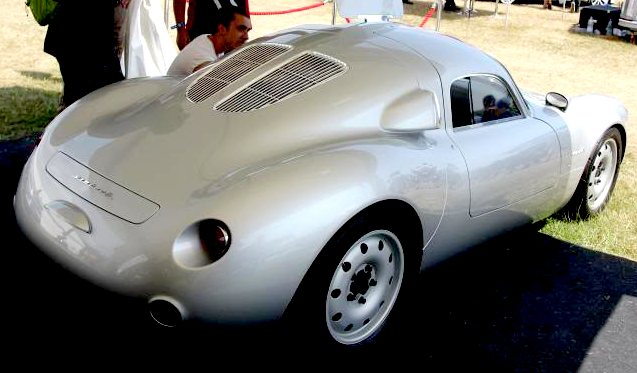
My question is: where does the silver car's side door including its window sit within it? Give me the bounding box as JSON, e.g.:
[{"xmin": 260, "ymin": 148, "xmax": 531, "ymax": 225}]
[{"xmin": 450, "ymin": 75, "xmax": 561, "ymax": 217}]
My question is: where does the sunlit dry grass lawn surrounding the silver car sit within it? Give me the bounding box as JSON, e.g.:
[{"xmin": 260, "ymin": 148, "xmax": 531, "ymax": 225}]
[{"xmin": 0, "ymin": 0, "xmax": 637, "ymax": 261}]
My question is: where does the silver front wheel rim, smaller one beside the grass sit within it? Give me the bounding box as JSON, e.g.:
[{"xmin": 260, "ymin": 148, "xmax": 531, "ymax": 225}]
[{"xmin": 586, "ymin": 139, "xmax": 617, "ymax": 211}]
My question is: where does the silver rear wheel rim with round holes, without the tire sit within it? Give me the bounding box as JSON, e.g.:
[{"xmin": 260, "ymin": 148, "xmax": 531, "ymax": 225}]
[{"xmin": 326, "ymin": 230, "xmax": 404, "ymax": 345}]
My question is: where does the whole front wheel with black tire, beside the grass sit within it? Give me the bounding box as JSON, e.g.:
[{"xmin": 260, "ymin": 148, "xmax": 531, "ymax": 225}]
[{"xmin": 565, "ymin": 128, "xmax": 624, "ymax": 219}]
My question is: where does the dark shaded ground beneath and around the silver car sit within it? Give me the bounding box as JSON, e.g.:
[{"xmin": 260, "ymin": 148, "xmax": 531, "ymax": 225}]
[{"xmin": 0, "ymin": 138, "xmax": 637, "ymax": 372}]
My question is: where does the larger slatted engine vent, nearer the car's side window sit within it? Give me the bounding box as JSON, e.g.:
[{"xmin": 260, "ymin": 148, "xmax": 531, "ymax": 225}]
[{"xmin": 214, "ymin": 52, "xmax": 347, "ymax": 112}]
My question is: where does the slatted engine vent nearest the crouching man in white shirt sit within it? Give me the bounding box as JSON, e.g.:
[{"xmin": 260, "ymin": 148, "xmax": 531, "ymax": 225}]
[{"xmin": 186, "ymin": 43, "xmax": 292, "ymax": 102}]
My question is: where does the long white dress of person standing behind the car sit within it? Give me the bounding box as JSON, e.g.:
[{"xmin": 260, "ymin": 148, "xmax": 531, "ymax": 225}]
[{"xmin": 118, "ymin": 0, "xmax": 178, "ymax": 79}]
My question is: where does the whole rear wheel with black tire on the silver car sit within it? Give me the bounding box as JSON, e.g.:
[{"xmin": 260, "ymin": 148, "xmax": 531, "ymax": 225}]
[{"xmin": 286, "ymin": 211, "xmax": 422, "ymax": 349}]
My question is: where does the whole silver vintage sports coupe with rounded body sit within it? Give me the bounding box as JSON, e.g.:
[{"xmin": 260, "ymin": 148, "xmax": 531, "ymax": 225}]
[{"xmin": 14, "ymin": 4, "xmax": 627, "ymax": 347}]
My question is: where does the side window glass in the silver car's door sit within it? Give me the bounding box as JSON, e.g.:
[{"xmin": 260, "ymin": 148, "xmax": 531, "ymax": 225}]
[{"xmin": 451, "ymin": 75, "xmax": 520, "ymax": 128}]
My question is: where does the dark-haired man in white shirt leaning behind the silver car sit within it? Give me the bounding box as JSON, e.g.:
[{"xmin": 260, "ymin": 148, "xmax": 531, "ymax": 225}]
[{"xmin": 167, "ymin": 9, "xmax": 252, "ymax": 76}]
